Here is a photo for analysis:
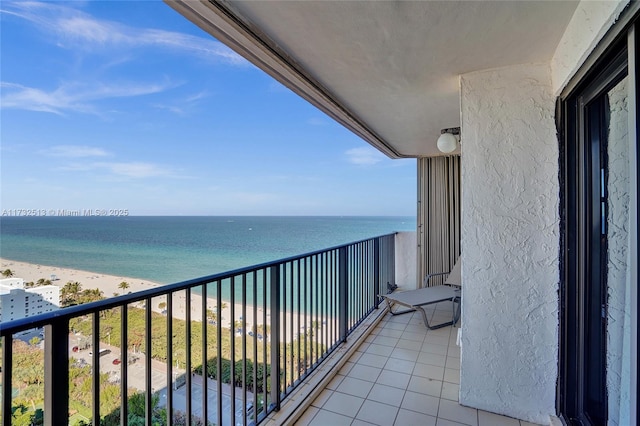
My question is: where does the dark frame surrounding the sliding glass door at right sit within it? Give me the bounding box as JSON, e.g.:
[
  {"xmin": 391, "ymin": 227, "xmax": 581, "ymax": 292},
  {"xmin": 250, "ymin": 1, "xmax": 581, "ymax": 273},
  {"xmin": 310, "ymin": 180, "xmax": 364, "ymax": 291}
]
[{"xmin": 556, "ymin": 15, "xmax": 640, "ymax": 425}]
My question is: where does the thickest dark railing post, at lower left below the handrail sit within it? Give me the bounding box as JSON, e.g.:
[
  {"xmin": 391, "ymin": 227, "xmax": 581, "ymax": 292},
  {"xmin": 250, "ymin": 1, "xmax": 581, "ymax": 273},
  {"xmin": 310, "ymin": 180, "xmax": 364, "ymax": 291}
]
[{"xmin": 44, "ymin": 318, "xmax": 69, "ymax": 425}]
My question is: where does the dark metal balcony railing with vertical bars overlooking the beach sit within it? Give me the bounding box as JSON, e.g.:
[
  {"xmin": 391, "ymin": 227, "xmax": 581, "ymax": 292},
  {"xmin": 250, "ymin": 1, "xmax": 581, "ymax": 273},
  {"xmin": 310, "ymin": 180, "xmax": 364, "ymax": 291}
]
[{"xmin": 0, "ymin": 234, "xmax": 395, "ymax": 426}]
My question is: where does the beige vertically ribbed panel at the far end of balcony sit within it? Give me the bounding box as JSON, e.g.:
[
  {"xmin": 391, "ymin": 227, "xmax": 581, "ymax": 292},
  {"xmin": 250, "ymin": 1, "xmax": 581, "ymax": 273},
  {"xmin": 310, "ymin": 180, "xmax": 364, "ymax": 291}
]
[{"xmin": 417, "ymin": 155, "xmax": 461, "ymax": 286}]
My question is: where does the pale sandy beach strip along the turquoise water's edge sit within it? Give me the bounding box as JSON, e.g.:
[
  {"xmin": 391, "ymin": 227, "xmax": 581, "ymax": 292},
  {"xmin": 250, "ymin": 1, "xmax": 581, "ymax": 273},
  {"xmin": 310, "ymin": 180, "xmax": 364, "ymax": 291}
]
[{"xmin": 0, "ymin": 258, "xmax": 320, "ymax": 341}]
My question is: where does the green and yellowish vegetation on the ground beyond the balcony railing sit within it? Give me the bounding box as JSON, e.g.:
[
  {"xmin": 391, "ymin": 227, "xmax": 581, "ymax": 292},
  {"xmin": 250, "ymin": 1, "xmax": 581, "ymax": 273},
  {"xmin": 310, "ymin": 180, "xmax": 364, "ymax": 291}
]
[{"xmin": 3, "ymin": 282, "xmax": 324, "ymax": 426}]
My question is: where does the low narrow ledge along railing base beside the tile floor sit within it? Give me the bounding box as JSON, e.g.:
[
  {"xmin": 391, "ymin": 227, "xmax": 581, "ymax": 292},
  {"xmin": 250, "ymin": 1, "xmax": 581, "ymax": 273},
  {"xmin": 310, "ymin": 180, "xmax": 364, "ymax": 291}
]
[{"xmin": 262, "ymin": 304, "xmax": 388, "ymax": 426}]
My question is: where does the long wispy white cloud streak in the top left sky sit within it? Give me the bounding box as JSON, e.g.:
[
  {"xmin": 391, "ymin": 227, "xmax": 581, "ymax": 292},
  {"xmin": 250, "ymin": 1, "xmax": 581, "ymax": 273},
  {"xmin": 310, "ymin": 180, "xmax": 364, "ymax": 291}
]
[{"xmin": 0, "ymin": 1, "xmax": 248, "ymax": 66}]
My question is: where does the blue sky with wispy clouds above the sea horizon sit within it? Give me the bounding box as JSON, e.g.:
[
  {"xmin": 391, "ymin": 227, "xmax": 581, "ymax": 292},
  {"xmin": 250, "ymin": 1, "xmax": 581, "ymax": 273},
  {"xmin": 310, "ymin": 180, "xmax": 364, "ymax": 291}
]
[{"xmin": 0, "ymin": 0, "xmax": 416, "ymax": 216}]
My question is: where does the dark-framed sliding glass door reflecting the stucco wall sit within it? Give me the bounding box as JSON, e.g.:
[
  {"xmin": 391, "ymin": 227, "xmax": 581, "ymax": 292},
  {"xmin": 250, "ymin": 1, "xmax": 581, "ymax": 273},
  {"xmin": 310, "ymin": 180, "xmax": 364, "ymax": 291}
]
[{"xmin": 558, "ymin": 29, "xmax": 637, "ymax": 425}]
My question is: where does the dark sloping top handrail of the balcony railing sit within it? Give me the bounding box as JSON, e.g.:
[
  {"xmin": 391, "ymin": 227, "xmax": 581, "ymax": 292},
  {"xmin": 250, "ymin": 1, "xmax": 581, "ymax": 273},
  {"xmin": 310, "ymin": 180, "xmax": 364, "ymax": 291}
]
[{"xmin": 0, "ymin": 232, "xmax": 397, "ymax": 337}]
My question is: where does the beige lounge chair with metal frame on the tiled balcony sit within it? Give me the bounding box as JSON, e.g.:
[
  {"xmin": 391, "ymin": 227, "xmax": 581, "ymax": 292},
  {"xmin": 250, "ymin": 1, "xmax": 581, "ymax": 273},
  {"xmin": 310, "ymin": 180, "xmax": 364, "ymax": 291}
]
[{"xmin": 382, "ymin": 258, "xmax": 462, "ymax": 330}]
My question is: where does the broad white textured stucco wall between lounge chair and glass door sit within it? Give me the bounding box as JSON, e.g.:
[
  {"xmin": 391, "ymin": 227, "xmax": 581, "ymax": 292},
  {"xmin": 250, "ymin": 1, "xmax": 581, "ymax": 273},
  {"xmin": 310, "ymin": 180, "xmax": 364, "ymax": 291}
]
[{"xmin": 460, "ymin": 64, "xmax": 559, "ymax": 424}]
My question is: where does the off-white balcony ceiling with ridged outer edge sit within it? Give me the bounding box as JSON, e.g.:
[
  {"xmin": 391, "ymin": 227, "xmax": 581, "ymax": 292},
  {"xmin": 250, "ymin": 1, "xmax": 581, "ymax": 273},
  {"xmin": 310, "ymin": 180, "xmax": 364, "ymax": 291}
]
[{"xmin": 165, "ymin": 0, "xmax": 578, "ymax": 158}]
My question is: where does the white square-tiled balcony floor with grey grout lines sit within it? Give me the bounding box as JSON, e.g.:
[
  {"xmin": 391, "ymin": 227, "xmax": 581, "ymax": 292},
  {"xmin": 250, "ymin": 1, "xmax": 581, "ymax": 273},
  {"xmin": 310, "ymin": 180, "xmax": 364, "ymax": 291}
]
[{"xmin": 296, "ymin": 306, "xmax": 533, "ymax": 426}]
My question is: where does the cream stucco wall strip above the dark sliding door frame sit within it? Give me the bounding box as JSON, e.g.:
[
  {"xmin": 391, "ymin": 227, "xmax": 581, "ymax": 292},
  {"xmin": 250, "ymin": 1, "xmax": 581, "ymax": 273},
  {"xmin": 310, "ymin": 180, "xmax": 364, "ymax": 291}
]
[{"xmin": 551, "ymin": 0, "xmax": 629, "ymax": 94}]
